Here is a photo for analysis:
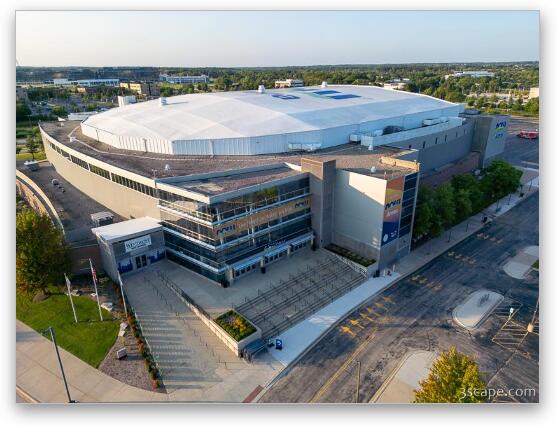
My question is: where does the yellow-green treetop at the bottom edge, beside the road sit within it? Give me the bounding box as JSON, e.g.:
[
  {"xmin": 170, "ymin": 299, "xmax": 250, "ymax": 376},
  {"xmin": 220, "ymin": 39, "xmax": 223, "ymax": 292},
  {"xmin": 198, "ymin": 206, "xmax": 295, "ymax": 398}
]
[{"xmin": 414, "ymin": 347, "xmax": 487, "ymax": 403}]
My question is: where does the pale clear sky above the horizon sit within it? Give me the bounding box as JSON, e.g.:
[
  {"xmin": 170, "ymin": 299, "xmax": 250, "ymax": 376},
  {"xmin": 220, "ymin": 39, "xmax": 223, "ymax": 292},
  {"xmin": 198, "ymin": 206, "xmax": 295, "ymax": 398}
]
[{"xmin": 16, "ymin": 11, "xmax": 539, "ymax": 67}]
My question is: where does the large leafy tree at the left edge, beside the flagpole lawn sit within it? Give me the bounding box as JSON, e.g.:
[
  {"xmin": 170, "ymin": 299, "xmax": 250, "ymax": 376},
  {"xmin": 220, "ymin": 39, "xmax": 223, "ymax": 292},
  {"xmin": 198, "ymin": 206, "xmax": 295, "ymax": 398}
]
[{"xmin": 16, "ymin": 209, "xmax": 70, "ymax": 294}]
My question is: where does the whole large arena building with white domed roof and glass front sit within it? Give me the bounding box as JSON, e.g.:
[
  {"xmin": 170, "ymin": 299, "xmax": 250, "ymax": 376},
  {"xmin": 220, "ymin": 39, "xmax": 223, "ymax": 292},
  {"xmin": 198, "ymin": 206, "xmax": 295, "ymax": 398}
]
[{"xmin": 41, "ymin": 83, "xmax": 506, "ymax": 286}]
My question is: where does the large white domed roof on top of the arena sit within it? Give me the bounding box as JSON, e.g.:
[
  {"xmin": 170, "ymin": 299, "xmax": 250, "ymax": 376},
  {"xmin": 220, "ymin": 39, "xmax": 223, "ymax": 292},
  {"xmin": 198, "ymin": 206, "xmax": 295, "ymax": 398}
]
[{"xmin": 82, "ymin": 85, "xmax": 463, "ymax": 155}]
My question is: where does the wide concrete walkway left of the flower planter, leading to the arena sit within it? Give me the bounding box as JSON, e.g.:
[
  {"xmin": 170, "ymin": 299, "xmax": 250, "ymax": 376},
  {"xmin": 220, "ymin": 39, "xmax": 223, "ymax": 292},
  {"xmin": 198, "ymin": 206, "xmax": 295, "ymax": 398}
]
[{"xmin": 124, "ymin": 271, "xmax": 282, "ymax": 402}]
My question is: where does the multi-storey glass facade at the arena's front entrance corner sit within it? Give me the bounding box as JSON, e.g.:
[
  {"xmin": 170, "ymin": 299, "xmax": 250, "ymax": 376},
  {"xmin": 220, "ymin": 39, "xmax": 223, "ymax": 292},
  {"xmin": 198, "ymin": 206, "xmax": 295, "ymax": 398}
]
[{"xmin": 161, "ymin": 178, "xmax": 311, "ymax": 281}]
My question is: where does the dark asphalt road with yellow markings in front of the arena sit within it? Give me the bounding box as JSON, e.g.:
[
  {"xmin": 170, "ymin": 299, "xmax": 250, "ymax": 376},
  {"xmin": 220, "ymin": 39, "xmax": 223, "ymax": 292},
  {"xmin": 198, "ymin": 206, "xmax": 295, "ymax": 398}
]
[{"xmin": 260, "ymin": 193, "xmax": 539, "ymax": 403}]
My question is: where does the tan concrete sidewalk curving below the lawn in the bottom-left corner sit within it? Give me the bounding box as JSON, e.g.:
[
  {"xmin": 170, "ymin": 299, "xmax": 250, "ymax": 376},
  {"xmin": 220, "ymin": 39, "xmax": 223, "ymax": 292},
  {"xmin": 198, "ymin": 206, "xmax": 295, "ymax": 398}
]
[{"xmin": 16, "ymin": 320, "xmax": 168, "ymax": 403}]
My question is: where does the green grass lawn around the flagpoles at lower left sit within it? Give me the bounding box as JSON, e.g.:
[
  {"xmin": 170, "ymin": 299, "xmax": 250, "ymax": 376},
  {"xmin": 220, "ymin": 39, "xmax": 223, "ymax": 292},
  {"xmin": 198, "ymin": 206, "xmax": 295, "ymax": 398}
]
[{"xmin": 16, "ymin": 293, "xmax": 120, "ymax": 368}]
